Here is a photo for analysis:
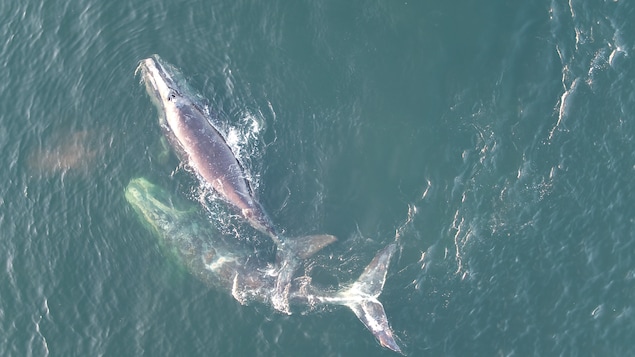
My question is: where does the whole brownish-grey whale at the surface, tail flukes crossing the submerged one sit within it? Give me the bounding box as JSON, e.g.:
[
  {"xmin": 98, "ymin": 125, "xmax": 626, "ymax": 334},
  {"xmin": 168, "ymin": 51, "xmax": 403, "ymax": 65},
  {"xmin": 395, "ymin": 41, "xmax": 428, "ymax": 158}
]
[{"xmin": 135, "ymin": 55, "xmax": 336, "ymax": 313}]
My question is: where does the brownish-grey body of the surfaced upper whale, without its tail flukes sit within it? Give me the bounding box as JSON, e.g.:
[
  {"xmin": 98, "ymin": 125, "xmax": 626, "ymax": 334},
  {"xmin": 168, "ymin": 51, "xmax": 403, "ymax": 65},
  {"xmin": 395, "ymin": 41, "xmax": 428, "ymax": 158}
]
[{"xmin": 135, "ymin": 55, "xmax": 278, "ymax": 240}]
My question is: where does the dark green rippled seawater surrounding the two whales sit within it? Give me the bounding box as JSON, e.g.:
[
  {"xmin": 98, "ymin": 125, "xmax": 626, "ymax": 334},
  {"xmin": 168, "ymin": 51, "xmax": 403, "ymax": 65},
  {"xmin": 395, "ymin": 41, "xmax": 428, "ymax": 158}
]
[{"xmin": 0, "ymin": 0, "xmax": 635, "ymax": 356}]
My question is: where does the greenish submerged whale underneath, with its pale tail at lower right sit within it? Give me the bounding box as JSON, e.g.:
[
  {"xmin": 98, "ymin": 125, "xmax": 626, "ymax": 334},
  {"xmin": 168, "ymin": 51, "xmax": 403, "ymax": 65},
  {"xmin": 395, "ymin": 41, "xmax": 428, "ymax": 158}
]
[{"xmin": 124, "ymin": 177, "xmax": 402, "ymax": 353}]
